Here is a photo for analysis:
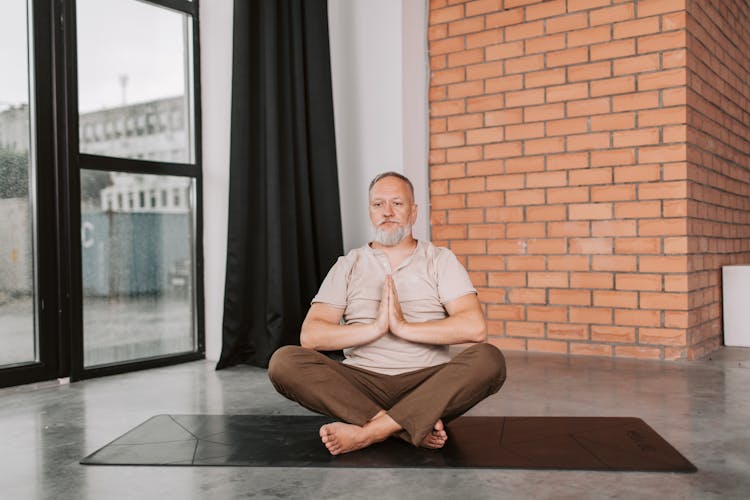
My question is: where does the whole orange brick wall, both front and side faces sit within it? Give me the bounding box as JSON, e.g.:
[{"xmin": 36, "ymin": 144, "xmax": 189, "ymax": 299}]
[{"xmin": 428, "ymin": 0, "xmax": 750, "ymax": 359}]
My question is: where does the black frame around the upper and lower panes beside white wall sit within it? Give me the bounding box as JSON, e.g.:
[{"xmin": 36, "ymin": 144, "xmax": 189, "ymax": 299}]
[{"xmin": 60, "ymin": 0, "xmax": 205, "ymax": 380}]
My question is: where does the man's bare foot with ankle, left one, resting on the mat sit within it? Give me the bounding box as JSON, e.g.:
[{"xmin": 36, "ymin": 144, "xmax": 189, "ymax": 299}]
[{"xmin": 320, "ymin": 411, "xmax": 401, "ymax": 455}]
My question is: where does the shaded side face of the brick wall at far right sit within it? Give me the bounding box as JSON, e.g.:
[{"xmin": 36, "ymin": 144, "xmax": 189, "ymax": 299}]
[{"xmin": 687, "ymin": 0, "xmax": 750, "ymax": 356}]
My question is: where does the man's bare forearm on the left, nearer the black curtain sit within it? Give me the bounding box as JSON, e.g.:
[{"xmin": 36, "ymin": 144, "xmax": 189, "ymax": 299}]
[{"xmin": 300, "ymin": 320, "xmax": 383, "ymax": 351}]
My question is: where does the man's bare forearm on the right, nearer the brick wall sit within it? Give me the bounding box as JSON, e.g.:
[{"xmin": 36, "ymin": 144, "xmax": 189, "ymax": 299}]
[{"xmin": 393, "ymin": 311, "xmax": 487, "ymax": 345}]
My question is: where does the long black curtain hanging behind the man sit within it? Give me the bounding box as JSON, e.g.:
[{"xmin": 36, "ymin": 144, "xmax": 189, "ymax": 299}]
[{"xmin": 216, "ymin": 0, "xmax": 343, "ymax": 369}]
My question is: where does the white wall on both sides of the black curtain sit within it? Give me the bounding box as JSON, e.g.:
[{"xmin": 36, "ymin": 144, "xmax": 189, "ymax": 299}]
[{"xmin": 200, "ymin": 0, "xmax": 429, "ymax": 360}]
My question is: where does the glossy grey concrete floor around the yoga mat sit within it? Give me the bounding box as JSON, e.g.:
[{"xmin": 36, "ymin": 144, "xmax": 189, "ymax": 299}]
[{"xmin": 0, "ymin": 348, "xmax": 750, "ymax": 500}]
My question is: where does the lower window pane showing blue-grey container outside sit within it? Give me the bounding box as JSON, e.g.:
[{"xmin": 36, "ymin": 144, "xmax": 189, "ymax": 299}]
[{"xmin": 81, "ymin": 170, "xmax": 195, "ymax": 367}]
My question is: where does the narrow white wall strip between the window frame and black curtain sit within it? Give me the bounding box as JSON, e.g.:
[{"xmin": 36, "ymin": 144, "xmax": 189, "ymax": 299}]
[{"xmin": 200, "ymin": 0, "xmax": 233, "ymax": 360}]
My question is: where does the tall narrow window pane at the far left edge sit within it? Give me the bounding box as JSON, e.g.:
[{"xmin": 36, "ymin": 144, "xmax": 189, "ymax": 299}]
[{"xmin": 0, "ymin": 0, "xmax": 38, "ymax": 365}]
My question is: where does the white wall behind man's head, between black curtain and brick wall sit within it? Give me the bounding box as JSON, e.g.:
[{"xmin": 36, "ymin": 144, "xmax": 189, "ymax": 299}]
[{"xmin": 328, "ymin": 0, "xmax": 429, "ymax": 251}]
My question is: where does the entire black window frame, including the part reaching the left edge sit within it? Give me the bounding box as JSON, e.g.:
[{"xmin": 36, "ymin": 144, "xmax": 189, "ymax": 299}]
[{"xmin": 0, "ymin": 0, "xmax": 205, "ymax": 387}]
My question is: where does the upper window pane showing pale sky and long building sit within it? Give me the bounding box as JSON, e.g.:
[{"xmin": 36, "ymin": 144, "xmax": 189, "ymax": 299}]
[{"xmin": 76, "ymin": 0, "xmax": 194, "ymax": 163}]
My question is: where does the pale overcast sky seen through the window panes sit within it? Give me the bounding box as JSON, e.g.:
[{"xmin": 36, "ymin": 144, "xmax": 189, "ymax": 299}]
[{"xmin": 0, "ymin": 0, "xmax": 185, "ymax": 112}]
